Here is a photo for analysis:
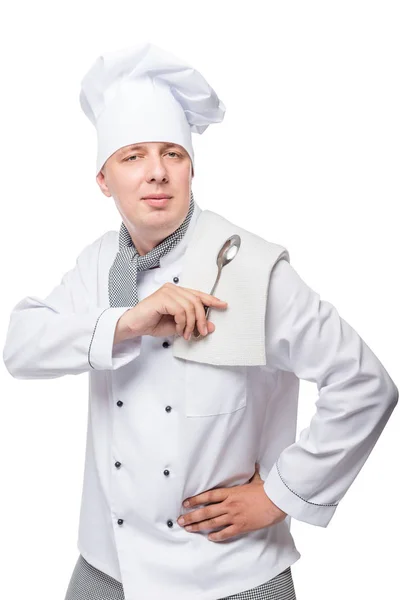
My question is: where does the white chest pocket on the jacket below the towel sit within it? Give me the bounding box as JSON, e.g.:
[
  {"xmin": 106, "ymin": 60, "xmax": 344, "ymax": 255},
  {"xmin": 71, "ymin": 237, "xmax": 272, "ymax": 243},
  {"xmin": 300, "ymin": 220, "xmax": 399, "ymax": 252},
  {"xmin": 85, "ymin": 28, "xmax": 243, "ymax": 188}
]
[{"xmin": 185, "ymin": 360, "xmax": 247, "ymax": 417}]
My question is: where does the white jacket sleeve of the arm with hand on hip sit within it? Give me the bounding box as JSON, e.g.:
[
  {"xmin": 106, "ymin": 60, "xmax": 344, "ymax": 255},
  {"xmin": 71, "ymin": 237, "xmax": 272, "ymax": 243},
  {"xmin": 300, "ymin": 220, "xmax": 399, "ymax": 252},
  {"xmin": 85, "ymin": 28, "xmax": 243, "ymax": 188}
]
[{"xmin": 264, "ymin": 260, "xmax": 399, "ymax": 527}]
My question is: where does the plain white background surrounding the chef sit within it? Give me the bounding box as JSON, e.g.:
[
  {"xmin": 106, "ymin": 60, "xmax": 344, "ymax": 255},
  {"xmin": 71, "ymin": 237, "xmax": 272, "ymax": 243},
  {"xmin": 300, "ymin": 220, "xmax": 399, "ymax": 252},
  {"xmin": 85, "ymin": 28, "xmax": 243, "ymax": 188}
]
[{"xmin": 0, "ymin": 0, "xmax": 400, "ymax": 600}]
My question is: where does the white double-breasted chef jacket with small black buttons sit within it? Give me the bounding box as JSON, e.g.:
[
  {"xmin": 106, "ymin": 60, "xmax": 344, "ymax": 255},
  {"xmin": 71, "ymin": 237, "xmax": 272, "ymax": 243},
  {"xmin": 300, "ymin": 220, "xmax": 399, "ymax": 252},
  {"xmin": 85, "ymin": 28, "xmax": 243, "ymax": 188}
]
[{"xmin": 3, "ymin": 203, "xmax": 399, "ymax": 600}]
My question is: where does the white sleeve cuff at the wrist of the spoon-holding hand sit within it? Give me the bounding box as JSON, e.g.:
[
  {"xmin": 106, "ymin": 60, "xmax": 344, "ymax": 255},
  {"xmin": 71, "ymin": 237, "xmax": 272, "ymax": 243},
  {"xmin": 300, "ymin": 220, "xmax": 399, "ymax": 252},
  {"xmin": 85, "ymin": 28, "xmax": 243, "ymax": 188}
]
[{"xmin": 88, "ymin": 306, "xmax": 142, "ymax": 371}]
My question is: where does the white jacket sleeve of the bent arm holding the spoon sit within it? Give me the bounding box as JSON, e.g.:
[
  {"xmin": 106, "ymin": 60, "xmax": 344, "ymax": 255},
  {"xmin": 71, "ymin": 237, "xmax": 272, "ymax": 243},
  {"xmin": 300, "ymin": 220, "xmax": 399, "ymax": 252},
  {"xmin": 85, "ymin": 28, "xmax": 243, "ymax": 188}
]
[{"xmin": 3, "ymin": 234, "xmax": 141, "ymax": 379}]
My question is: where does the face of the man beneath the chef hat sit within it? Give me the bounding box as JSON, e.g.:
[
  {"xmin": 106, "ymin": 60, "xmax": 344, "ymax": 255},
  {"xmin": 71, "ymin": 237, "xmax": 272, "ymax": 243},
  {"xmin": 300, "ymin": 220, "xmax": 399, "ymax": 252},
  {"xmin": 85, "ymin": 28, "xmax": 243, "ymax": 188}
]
[{"xmin": 96, "ymin": 142, "xmax": 193, "ymax": 254}]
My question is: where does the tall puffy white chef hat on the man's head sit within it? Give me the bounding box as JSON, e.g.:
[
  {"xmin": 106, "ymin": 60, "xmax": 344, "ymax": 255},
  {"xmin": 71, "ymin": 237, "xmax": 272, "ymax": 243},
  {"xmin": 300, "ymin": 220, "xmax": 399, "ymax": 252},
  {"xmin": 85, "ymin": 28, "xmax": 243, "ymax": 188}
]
[{"xmin": 79, "ymin": 43, "xmax": 225, "ymax": 175}]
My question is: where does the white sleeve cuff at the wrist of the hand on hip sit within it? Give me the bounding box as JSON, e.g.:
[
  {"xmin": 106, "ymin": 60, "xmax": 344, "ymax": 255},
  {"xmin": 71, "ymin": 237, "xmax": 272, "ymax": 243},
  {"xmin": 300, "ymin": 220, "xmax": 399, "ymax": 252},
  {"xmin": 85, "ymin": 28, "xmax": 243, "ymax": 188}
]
[{"xmin": 264, "ymin": 464, "xmax": 338, "ymax": 527}]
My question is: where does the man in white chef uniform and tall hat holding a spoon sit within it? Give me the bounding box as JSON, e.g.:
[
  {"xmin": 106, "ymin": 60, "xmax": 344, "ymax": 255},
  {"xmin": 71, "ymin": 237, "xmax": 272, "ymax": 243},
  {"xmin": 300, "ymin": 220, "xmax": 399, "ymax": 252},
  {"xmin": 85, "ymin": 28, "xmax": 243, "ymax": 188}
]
[{"xmin": 3, "ymin": 43, "xmax": 398, "ymax": 600}]
